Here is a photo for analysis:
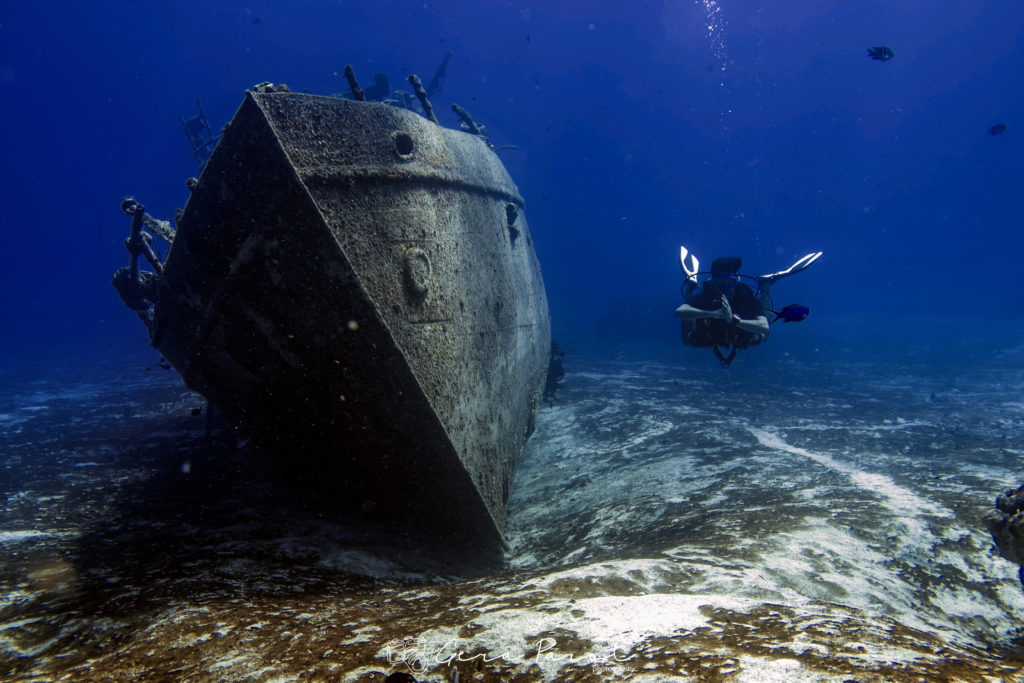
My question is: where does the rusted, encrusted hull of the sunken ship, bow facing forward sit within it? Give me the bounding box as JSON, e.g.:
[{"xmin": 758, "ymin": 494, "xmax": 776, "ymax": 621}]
[{"xmin": 152, "ymin": 92, "xmax": 550, "ymax": 541}]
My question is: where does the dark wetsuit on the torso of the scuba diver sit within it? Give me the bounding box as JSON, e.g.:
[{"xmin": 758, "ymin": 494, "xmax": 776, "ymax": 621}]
[{"xmin": 683, "ymin": 280, "xmax": 767, "ymax": 350}]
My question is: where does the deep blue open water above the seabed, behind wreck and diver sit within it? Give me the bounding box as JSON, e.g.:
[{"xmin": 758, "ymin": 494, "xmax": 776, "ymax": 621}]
[{"xmin": 0, "ymin": 0, "xmax": 1024, "ymax": 362}]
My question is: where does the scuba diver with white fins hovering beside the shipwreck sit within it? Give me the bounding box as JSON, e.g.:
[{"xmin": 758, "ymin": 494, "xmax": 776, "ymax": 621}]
[{"xmin": 676, "ymin": 247, "xmax": 821, "ymax": 368}]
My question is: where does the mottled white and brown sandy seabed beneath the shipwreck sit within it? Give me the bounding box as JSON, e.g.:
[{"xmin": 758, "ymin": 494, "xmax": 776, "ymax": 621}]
[{"xmin": 0, "ymin": 354, "xmax": 1024, "ymax": 681}]
